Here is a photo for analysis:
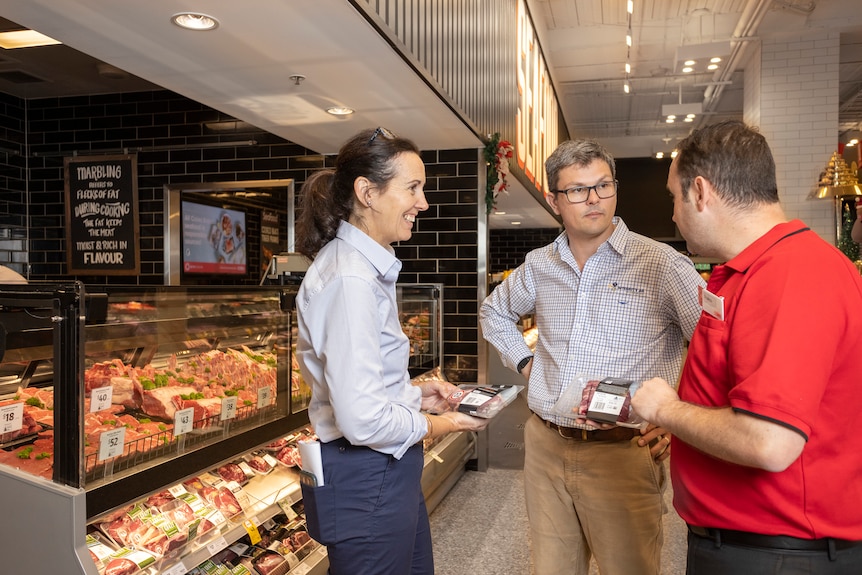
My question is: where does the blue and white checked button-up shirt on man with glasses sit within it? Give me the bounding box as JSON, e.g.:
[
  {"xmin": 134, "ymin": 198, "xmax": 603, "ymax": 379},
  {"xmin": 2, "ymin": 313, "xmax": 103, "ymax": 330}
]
[{"xmin": 479, "ymin": 217, "xmax": 706, "ymax": 427}]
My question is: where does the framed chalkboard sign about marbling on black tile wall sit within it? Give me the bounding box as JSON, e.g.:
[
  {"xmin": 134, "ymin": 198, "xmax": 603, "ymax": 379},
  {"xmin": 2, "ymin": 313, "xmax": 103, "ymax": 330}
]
[{"xmin": 64, "ymin": 155, "xmax": 141, "ymax": 275}]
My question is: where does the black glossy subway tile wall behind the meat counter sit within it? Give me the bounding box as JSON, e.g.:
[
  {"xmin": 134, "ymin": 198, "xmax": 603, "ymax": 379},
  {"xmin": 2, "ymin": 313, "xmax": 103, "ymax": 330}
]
[{"xmin": 0, "ymin": 90, "xmax": 479, "ymax": 382}]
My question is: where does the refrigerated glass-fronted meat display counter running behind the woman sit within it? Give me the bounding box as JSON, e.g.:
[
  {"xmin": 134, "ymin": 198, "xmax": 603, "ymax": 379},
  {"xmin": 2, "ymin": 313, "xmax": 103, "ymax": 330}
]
[{"xmin": 0, "ymin": 282, "xmax": 476, "ymax": 575}]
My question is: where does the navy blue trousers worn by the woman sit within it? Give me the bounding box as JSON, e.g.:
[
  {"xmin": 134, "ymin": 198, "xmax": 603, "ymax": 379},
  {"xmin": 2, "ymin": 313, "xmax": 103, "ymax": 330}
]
[{"xmin": 302, "ymin": 439, "xmax": 434, "ymax": 575}]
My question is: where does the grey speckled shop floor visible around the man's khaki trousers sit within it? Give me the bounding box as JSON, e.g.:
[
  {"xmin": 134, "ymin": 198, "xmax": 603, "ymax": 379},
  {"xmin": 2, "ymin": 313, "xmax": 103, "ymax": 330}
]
[{"xmin": 431, "ymin": 467, "xmax": 686, "ymax": 575}]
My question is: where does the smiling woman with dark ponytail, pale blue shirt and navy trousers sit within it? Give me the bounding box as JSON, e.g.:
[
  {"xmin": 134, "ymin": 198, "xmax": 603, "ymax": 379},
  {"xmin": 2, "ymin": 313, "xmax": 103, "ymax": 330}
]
[{"xmin": 296, "ymin": 128, "xmax": 487, "ymax": 575}]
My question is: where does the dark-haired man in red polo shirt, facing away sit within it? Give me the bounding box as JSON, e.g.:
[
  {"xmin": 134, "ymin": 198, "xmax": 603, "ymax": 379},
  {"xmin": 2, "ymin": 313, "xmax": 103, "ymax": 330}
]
[{"xmin": 632, "ymin": 122, "xmax": 862, "ymax": 575}]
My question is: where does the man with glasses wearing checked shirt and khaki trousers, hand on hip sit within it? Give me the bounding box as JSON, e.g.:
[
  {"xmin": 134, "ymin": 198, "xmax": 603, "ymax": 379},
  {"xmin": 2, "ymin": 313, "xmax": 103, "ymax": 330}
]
[{"xmin": 479, "ymin": 140, "xmax": 705, "ymax": 575}]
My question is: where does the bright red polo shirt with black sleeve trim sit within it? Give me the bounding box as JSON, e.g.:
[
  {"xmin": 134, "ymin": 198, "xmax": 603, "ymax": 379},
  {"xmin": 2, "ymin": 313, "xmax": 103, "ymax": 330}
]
[{"xmin": 671, "ymin": 220, "xmax": 862, "ymax": 540}]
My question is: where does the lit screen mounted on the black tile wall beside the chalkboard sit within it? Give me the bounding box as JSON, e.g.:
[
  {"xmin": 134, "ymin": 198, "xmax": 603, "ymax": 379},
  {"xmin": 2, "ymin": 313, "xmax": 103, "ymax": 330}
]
[{"xmin": 180, "ymin": 201, "xmax": 247, "ymax": 275}]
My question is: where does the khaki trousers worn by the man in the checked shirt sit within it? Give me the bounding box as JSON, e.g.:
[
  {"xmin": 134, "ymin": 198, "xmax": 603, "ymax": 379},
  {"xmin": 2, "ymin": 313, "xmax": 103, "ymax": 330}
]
[{"xmin": 524, "ymin": 415, "xmax": 666, "ymax": 575}]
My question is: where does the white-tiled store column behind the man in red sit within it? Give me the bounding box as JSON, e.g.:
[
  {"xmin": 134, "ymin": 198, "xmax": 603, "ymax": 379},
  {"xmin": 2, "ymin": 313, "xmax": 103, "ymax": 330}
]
[{"xmin": 743, "ymin": 30, "xmax": 841, "ymax": 243}]
